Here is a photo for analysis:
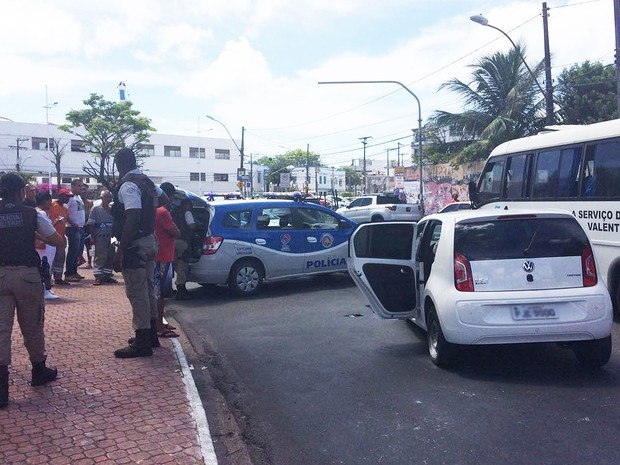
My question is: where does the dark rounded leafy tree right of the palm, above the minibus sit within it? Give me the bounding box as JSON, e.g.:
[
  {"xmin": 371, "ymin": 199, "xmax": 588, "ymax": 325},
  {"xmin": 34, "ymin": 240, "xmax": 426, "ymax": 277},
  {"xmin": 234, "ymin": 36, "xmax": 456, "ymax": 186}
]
[{"xmin": 555, "ymin": 61, "xmax": 620, "ymax": 124}]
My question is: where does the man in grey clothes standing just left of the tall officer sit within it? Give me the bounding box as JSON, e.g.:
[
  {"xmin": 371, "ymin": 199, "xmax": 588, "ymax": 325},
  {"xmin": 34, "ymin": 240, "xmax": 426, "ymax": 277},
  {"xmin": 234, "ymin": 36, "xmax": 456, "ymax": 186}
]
[{"xmin": 86, "ymin": 190, "xmax": 116, "ymax": 286}]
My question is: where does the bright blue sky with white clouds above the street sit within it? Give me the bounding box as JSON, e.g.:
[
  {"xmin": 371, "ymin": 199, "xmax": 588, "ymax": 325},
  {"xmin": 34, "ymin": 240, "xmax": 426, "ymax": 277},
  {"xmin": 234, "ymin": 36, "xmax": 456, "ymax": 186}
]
[{"xmin": 0, "ymin": 0, "xmax": 615, "ymax": 166}]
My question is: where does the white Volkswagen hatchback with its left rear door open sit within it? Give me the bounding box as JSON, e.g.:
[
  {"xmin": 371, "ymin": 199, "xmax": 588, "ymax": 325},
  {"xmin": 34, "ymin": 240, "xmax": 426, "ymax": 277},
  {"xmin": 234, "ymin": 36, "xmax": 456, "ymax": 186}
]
[{"xmin": 348, "ymin": 210, "xmax": 613, "ymax": 368}]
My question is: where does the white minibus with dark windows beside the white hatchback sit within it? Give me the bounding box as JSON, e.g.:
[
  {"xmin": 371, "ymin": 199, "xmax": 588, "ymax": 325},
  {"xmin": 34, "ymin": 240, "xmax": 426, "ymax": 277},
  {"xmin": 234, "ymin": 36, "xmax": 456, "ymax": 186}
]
[{"xmin": 469, "ymin": 119, "xmax": 620, "ymax": 313}]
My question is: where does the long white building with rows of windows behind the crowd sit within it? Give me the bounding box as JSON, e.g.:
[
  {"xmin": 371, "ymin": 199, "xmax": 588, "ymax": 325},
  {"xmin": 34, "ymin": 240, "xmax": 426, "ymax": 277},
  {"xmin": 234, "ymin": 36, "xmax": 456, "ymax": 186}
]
[{"xmin": 0, "ymin": 121, "xmax": 265, "ymax": 194}]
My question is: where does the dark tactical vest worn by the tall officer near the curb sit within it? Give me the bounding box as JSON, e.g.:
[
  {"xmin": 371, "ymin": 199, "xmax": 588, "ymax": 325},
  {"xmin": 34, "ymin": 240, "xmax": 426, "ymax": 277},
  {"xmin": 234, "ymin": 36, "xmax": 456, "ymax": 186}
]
[{"xmin": 112, "ymin": 173, "xmax": 157, "ymax": 240}]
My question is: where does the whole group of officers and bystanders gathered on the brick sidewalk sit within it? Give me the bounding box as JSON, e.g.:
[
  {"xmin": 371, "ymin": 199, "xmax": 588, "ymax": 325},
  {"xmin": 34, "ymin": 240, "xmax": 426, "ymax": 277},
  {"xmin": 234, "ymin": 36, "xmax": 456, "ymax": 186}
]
[{"xmin": 0, "ymin": 148, "xmax": 195, "ymax": 408}]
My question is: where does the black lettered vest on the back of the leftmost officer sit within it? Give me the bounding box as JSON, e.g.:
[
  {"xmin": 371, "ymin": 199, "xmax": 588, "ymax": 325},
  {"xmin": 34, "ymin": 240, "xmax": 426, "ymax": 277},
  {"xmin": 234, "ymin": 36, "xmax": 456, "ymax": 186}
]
[{"xmin": 0, "ymin": 201, "xmax": 40, "ymax": 268}]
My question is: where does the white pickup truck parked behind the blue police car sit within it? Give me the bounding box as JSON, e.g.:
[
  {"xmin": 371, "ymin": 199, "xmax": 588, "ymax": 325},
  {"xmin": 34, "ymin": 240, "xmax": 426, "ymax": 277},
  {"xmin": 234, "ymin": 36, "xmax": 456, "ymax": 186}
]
[{"xmin": 337, "ymin": 194, "xmax": 422, "ymax": 223}]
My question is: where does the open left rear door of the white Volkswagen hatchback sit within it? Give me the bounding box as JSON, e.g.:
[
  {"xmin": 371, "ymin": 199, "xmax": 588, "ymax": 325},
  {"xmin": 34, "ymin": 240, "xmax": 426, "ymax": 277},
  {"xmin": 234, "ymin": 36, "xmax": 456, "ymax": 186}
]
[{"xmin": 347, "ymin": 222, "xmax": 417, "ymax": 319}]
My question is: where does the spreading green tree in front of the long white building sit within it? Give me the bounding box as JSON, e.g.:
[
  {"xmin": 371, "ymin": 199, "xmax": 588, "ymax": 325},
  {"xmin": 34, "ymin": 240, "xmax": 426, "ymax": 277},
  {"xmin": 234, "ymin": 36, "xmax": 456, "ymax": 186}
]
[{"xmin": 59, "ymin": 94, "xmax": 155, "ymax": 188}]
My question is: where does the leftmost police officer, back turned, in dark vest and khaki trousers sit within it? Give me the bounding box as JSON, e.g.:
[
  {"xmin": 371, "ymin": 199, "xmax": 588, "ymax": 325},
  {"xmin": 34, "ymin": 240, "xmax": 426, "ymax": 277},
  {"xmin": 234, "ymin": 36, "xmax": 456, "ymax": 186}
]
[{"xmin": 0, "ymin": 173, "xmax": 66, "ymax": 408}]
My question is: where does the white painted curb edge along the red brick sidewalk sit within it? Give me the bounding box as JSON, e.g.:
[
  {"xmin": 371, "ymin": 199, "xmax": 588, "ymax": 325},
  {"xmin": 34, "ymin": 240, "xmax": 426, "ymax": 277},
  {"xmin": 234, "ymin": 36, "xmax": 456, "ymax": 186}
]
[{"xmin": 170, "ymin": 339, "xmax": 218, "ymax": 465}]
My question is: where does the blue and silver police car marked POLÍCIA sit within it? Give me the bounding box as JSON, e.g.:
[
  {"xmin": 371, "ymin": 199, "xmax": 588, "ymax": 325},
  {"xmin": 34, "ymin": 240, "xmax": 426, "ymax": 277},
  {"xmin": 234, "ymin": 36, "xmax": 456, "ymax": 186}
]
[{"xmin": 189, "ymin": 199, "xmax": 356, "ymax": 295}]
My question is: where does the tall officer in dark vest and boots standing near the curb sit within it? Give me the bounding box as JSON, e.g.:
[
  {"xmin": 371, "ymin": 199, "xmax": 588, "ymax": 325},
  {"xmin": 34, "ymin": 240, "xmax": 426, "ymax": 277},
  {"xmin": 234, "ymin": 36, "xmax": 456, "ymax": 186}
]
[{"xmin": 112, "ymin": 148, "xmax": 168, "ymax": 358}]
